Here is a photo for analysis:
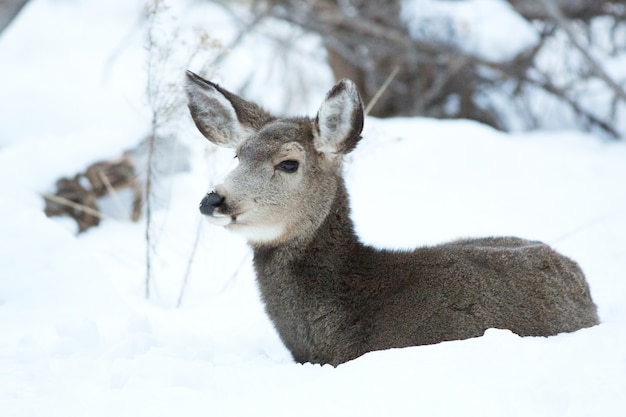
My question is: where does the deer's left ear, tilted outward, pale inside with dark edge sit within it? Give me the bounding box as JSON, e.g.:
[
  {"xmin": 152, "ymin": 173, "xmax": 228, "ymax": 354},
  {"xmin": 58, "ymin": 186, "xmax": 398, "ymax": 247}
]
[{"xmin": 186, "ymin": 71, "xmax": 271, "ymax": 148}]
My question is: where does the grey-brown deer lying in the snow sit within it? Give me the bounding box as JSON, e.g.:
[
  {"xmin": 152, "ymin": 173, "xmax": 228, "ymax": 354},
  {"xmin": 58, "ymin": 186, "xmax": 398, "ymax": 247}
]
[{"xmin": 187, "ymin": 72, "xmax": 598, "ymax": 365}]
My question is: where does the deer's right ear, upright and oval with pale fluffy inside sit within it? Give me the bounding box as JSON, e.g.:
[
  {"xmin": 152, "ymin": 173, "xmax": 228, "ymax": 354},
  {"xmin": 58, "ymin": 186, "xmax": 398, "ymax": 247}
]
[{"xmin": 313, "ymin": 79, "xmax": 363, "ymax": 154}]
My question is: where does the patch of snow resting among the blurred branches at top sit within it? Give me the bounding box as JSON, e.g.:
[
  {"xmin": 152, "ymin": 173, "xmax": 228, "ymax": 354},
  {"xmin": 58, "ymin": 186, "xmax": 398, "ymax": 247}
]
[{"xmin": 401, "ymin": 0, "xmax": 539, "ymax": 62}]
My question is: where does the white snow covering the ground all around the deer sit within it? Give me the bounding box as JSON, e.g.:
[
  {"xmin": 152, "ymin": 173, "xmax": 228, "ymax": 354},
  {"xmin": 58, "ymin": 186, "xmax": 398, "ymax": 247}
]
[{"xmin": 0, "ymin": 0, "xmax": 626, "ymax": 417}]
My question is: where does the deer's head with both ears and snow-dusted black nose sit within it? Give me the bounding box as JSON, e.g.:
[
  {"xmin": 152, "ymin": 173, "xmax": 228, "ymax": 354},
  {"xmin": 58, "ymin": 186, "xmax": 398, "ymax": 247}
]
[{"xmin": 187, "ymin": 72, "xmax": 363, "ymax": 246}]
